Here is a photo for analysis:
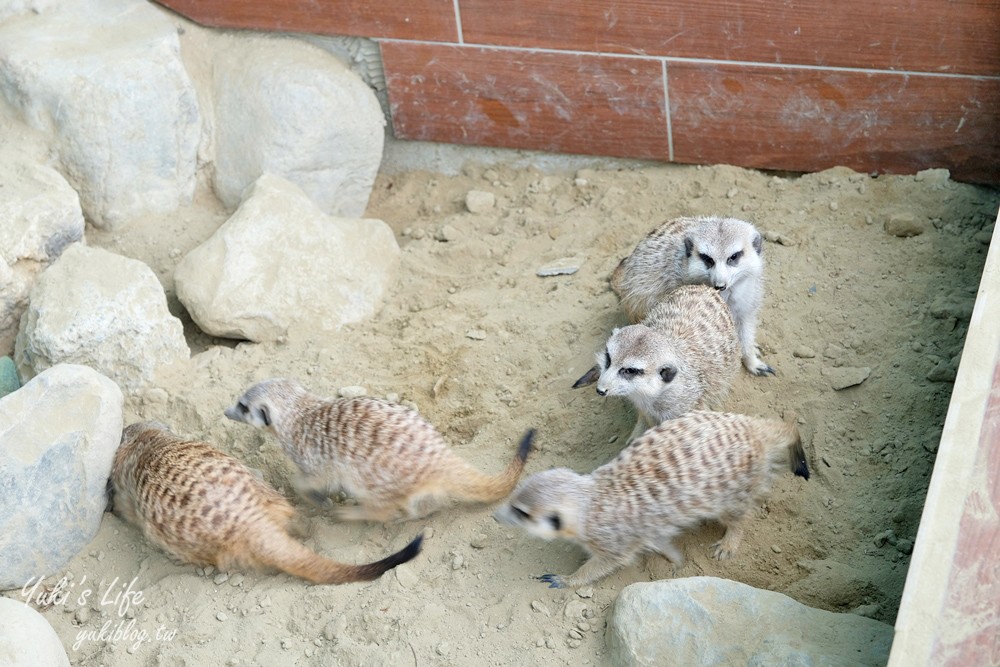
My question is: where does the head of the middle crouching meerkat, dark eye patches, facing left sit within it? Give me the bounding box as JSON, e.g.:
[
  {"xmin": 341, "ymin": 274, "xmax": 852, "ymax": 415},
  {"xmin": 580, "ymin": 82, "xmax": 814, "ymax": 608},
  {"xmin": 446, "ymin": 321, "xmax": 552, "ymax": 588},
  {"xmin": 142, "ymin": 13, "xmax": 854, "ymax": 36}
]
[{"xmin": 597, "ymin": 324, "xmax": 680, "ymax": 408}]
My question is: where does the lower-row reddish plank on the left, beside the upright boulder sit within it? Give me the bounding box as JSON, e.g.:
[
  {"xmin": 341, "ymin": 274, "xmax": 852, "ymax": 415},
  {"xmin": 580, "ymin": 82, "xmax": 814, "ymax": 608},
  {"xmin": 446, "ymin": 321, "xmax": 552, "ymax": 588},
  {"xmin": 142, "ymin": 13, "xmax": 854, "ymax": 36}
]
[{"xmin": 382, "ymin": 42, "xmax": 669, "ymax": 160}]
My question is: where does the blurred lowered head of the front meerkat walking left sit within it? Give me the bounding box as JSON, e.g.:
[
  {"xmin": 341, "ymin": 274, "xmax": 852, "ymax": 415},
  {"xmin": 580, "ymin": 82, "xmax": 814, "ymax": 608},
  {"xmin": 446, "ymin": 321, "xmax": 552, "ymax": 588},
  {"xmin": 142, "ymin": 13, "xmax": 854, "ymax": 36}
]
[{"xmin": 493, "ymin": 468, "xmax": 591, "ymax": 540}]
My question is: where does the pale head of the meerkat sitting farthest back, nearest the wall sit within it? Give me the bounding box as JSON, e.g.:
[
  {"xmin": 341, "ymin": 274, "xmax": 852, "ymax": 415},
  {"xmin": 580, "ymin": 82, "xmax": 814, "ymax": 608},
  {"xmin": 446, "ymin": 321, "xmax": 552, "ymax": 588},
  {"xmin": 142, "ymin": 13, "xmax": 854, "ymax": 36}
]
[{"xmin": 684, "ymin": 217, "xmax": 764, "ymax": 294}]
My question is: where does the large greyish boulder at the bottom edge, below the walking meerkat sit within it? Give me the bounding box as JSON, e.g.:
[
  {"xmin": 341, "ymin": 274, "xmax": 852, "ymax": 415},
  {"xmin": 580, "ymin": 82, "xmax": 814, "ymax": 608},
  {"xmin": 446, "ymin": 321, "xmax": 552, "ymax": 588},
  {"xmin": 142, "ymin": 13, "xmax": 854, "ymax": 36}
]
[{"xmin": 607, "ymin": 577, "xmax": 892, "ymax": 666}]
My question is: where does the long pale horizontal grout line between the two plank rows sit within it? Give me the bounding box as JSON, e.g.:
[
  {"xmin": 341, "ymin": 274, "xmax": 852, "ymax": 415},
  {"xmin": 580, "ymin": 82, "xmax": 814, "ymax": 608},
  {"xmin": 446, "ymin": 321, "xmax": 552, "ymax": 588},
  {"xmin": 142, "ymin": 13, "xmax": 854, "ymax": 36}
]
[{"xmin": 376, "ymin": 37, "xmax": 1000, "ymax": 81}]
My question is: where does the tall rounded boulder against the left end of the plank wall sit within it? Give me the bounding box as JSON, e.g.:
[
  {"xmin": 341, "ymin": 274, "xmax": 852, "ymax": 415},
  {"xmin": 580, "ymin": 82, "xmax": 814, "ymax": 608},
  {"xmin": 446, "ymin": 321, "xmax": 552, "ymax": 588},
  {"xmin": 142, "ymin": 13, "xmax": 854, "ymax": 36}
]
[{"xmin": 213, "ymin": 38, "xmax": 385, "ymax": 218}]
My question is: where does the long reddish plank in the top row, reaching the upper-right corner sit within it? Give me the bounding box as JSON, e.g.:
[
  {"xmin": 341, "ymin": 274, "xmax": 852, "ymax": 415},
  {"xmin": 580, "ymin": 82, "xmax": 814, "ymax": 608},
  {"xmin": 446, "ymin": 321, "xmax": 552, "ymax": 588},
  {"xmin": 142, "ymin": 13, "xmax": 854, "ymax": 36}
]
[{"xmin": 459, "ymin": 0, "xmax": 1000, "ymax": 75}]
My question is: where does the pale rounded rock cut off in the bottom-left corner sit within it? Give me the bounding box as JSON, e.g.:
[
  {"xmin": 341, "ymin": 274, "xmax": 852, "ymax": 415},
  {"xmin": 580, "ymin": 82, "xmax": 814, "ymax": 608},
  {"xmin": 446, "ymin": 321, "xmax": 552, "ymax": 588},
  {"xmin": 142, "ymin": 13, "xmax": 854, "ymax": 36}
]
[{"xmin": 0, "ymin": 597, "xmax": 69, "ymax": 667}]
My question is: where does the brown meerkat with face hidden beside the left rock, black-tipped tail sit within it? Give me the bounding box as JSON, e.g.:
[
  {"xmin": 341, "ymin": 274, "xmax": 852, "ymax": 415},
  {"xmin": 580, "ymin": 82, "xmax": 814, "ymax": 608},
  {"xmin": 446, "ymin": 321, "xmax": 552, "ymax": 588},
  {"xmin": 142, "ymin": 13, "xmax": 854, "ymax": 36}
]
[{"xmin": 108, "ymin": 422, "xmax": 423, "ymax": 584}]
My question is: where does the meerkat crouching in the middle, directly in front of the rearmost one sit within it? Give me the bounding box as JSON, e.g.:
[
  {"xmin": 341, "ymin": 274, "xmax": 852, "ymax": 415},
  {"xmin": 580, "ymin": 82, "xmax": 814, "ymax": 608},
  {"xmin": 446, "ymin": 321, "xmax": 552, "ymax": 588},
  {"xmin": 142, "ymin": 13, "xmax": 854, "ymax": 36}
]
[{"xmin": 573, "ymin": 285, "xmax": 740, "ymax": 442}]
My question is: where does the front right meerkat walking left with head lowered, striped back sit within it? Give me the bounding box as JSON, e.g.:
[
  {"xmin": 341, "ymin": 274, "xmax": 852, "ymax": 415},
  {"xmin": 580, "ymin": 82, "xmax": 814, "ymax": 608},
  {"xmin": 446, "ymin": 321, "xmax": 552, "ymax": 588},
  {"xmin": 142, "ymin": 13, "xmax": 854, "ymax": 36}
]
[{"xmin": 494, "ymin": 412, "xmax": 809, "ymax": 588}]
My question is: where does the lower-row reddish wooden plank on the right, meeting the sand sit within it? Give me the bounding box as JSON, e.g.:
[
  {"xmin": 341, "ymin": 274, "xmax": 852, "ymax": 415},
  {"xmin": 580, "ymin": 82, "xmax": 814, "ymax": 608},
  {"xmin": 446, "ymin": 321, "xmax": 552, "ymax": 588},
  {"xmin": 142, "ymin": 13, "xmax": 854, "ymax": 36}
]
[{"xmin": 667, "ymin": 62, "xmax": 1000, "ymax": 183}]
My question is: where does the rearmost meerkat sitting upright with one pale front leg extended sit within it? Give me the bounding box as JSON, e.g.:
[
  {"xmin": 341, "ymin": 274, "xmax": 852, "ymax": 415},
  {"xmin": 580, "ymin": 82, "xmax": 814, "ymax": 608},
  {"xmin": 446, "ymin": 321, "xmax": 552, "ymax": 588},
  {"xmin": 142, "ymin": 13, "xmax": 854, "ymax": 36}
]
[{"xmin": 611, "ymin": 216, "xmax": 774, "ymax": 375}]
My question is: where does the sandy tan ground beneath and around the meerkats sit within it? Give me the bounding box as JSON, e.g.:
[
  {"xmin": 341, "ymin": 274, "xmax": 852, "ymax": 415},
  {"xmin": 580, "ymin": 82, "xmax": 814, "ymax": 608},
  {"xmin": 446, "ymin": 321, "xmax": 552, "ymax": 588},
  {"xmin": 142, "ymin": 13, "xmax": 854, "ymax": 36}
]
[{"xmin": 8, "ymin": 154, "xmax": 1000, "ymax": 666}]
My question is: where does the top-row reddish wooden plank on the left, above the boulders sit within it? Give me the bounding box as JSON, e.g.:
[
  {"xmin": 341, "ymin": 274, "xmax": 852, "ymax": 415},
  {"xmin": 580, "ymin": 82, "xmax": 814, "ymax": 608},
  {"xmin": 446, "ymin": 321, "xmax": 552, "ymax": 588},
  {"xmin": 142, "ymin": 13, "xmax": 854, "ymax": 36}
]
[{"xmin": 157, "ymin": 0, "xmax": 459, "ymax": 41}]
